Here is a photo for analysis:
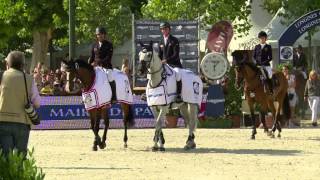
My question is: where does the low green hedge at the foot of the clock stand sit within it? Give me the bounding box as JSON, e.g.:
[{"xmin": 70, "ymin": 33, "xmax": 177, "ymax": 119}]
[{"xmin": 198, "ymin": 117, "xmax": 232, "ymax": 128}]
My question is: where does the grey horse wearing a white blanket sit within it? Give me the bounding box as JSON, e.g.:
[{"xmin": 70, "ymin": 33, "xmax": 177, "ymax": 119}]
[{"xmin": 139, "ymin": 42, "xmax": 203, "ymax": 151}]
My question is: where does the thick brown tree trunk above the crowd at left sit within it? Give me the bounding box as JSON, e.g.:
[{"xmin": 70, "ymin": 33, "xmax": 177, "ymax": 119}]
[{"xmin": 30, "ymin": 29, "xmax": 52, "ymax": 73}]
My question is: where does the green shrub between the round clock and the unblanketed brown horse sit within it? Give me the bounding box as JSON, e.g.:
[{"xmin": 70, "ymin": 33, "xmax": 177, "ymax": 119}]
[{"xmin": 225, "ymin": 66, "xmax": 243, "ymax": 115}]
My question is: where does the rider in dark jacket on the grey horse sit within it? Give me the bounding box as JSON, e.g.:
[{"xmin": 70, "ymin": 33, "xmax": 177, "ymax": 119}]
[{"xmin": 159, "ymin": 22, "xmax": 182, "ymax": 103}]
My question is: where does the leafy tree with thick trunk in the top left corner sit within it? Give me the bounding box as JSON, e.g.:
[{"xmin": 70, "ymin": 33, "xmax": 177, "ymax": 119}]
[{"xmin": 0, "ymin": 0, "xmax": 67, "ymax": 73}]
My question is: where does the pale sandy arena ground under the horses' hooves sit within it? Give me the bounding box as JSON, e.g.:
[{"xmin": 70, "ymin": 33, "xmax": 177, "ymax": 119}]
[{"xmin": 29, "ymin": 128, "xmax": 320, "ymax": 180}]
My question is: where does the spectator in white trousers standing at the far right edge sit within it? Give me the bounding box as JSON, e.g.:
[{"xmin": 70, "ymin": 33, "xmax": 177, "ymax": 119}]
[{"xmin": 304, "ymin": 70, "xmax": 320, "ymax": 126}]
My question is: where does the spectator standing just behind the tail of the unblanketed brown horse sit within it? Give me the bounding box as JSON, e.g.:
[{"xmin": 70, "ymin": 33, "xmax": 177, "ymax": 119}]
[{"xmin": 282, "ymin": 65, "xmax": 299, "ymax": 127}]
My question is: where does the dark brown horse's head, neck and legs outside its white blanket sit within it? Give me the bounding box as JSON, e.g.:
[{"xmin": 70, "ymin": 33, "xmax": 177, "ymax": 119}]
[{"xmin": 61, "ymin": 59, "xmax": 134, "ymax": 151}]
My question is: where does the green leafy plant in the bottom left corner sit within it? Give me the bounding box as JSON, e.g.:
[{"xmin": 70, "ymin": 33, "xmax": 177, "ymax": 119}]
[{"xmin": 0, "ymin": 150, "xmax": 45, "ymax": 180}]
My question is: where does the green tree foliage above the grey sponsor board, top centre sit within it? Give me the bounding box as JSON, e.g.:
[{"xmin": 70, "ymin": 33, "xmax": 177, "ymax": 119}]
[{"xmin": 142, "ymin": 0, "xmax": 251, "ymax": 33}]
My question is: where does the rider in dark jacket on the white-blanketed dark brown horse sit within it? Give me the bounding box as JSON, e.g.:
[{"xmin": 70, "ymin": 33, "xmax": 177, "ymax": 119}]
[{"xmin": 89, "ymin": 27, "xmax": 117, "ymax": 102}]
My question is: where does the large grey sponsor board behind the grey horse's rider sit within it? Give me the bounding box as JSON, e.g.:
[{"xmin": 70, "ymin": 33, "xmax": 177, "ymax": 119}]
[{"xmin": 134, "ymin": 20, "xmax": 199, "ymax": 87}]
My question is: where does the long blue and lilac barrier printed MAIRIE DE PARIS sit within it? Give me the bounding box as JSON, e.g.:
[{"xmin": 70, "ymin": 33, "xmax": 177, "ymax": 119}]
[{"xmin": 32, "ymin": 96, "xmax": 184, "ymax": 129}]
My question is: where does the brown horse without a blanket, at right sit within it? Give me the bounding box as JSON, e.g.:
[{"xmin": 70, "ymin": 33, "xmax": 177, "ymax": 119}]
[{"xmin": 232, "ymin": 51, "xmax": 290, "ymax": 139}]
